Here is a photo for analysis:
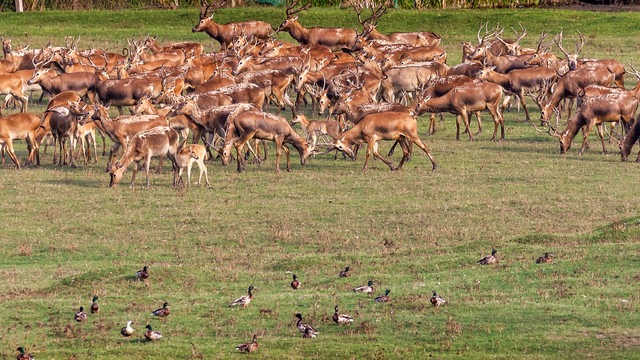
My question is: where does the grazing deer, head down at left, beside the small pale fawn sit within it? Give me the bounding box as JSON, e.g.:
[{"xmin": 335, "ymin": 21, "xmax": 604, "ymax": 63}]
[{"xmin": 109, "ymin": 126, "xmax": 180, "ymax": 189}]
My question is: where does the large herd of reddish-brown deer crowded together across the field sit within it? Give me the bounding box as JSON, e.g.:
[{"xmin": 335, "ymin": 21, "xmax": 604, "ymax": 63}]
[{"xmin": 0, "ymin": 0, "xmax": 640, "ymax": 186}]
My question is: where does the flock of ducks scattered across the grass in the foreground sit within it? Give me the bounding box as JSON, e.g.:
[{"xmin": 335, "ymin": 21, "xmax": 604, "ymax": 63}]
[{"xmin": 11, "ymin": 249, "xmax": 553, "ymax": 360}]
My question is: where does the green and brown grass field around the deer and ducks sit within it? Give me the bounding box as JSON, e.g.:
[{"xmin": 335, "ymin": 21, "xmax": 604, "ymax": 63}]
[{"xmin": 0, "ymin": 9, "xmax": 640, "ymax": 359}]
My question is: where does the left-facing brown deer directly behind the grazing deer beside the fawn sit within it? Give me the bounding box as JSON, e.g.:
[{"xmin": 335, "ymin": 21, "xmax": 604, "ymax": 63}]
[{"xmin": 79, "ymin": 105, "xmax": 168, "ymax": 172}]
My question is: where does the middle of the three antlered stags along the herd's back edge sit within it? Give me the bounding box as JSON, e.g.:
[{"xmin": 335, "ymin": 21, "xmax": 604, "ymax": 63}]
[{"xmin": 276, "ymin": 0, "xmax": 358, "ymax": 51}]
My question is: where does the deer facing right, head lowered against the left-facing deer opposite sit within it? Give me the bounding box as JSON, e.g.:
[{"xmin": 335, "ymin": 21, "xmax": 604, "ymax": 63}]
[{"xmin": 222, "ymin": 111, "xmax": 311, "ymax": 173}]
